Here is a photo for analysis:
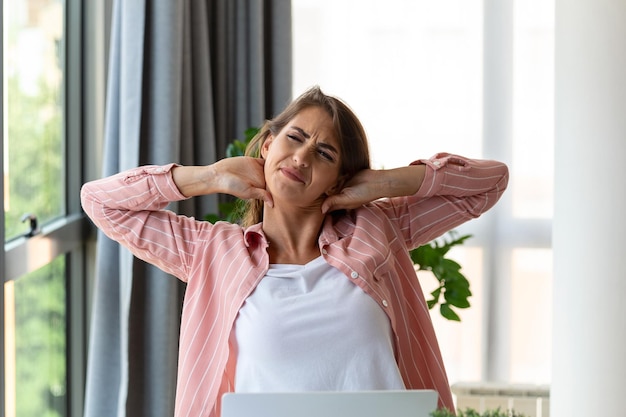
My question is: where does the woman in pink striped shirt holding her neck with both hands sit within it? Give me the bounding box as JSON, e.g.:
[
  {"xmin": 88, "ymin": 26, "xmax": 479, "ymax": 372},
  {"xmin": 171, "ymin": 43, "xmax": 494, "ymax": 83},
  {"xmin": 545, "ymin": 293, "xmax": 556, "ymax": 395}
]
[{"xmin": 82, "ymin": 87, "xmax": 508, "ymax": 417}]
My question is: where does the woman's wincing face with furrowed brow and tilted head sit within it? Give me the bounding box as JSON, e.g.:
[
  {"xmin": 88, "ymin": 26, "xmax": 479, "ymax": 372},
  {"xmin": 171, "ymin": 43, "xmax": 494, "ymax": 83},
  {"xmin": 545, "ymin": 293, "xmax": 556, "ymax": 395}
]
[{"xmin": 261, "ymin": 107, "xmax": 342, "ymax": 207}]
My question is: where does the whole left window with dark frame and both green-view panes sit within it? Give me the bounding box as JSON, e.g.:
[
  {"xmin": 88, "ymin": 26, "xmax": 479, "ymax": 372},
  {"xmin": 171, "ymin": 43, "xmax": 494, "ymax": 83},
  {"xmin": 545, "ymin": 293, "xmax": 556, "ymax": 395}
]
[{"xmin": 0, "ymin": 0, "xmax": 104, "ymax": 417}]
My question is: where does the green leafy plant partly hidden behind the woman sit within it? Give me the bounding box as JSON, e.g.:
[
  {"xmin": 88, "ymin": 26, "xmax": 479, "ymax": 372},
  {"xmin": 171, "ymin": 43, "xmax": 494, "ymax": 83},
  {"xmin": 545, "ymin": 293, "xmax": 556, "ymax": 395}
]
[{"xmin": 204, "ymin": 127, "xmax": 472, "ymax": 321}]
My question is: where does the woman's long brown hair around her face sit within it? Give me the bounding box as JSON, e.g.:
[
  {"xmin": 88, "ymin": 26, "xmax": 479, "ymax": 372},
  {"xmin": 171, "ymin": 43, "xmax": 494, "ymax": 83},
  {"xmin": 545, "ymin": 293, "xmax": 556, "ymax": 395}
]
[{"xmin": 236, "ymin": 86, "xmax": 370, "ymax": 227}]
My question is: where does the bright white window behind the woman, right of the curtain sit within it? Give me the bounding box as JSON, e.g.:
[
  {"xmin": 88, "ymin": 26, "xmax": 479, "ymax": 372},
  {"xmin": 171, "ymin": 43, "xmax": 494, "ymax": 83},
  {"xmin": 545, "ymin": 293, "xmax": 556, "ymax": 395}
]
[{"xmin": 292, "ymin": 0, "xmax": 554, "ymax": 384}]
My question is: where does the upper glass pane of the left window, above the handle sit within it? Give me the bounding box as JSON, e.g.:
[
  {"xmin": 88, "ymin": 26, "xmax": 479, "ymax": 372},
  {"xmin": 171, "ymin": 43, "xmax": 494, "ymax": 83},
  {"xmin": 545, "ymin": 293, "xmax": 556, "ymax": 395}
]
[{"xmin": 3, "ymin": 0, "xmax": 66, "ymax": 240}]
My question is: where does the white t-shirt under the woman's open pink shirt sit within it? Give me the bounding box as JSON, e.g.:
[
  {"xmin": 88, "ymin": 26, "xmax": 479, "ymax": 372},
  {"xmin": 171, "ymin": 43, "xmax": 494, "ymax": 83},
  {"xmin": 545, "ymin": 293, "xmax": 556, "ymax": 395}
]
[{"xmin": 234, "ymin": 257, "xmax": 404, "ymax": 392}]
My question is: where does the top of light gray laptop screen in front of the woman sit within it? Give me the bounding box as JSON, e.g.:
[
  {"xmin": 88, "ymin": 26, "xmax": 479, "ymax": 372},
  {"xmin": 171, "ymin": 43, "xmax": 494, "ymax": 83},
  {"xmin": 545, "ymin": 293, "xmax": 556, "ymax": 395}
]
[{"xmin": 222, "ymin": 390, "xmax": 438, "ymax": 417}]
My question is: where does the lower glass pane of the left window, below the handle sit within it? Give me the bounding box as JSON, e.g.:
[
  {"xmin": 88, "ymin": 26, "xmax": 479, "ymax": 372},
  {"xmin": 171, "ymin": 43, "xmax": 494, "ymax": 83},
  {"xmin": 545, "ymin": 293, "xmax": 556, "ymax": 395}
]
[{"xmin": 4, "ymin": 256, "xmax": 68, "ymax": 416}]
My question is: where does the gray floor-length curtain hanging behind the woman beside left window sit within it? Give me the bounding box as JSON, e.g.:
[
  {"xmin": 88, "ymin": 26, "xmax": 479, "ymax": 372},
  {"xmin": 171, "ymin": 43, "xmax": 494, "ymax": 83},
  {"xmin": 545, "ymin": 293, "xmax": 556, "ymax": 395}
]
[{"xmin": 85, "ymin": 0, "xmax": 291, "ymax": 417}]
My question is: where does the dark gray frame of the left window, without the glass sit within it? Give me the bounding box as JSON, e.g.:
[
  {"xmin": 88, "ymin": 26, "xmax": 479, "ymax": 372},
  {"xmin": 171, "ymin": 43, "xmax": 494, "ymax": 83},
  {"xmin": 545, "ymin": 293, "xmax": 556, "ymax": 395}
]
[{"xmin": 0, "ymin": 0, "xmax": 113, "ymax": 416}]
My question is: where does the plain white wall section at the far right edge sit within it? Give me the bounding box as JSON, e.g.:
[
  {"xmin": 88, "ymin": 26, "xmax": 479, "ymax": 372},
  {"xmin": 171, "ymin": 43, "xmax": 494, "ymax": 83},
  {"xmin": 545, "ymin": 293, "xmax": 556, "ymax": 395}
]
[{"xmin": 551, "ymin": 0, "xmax": 626, "ymax": 417}]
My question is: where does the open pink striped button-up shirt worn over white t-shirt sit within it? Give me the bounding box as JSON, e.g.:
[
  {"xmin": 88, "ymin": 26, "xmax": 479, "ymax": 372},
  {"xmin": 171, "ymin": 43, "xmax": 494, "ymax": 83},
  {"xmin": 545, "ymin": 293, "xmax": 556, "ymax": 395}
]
[{"xmin": 82, "ymin": 153, "xmax": 508, "ymax": 417}]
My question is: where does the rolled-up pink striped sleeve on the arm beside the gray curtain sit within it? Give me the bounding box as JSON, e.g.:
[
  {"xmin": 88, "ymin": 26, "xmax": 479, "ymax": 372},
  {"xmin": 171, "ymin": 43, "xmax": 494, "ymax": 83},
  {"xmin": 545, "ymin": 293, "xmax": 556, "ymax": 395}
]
[{"xmin": 81, "ymin": 164, "xmax": 197, "ymax": 280}]
